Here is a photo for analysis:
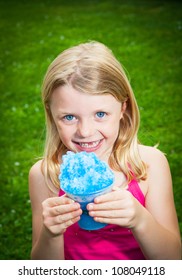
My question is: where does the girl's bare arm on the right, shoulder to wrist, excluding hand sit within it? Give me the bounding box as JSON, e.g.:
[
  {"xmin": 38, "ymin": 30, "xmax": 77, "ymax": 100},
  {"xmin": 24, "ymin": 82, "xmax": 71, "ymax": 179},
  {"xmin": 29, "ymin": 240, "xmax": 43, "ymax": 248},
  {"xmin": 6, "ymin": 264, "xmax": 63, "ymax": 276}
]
[{"xmin": 133, "ymin": 149, "xmax": 181, "ymax": 259}]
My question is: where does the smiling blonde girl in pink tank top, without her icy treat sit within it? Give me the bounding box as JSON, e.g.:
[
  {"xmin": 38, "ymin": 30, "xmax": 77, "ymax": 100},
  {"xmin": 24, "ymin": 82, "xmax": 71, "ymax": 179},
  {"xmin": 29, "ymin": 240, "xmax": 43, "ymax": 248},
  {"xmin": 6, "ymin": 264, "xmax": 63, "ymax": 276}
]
[{"xmin": 29, "ymin": 42, "xmax": 181, "ymax": 260}]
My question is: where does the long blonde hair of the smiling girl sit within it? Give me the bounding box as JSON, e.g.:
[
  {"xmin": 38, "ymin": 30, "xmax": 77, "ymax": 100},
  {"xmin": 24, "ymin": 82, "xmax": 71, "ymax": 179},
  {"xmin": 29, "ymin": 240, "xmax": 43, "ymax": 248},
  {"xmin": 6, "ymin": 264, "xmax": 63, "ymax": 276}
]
[{"xmin": 42, "ymin": 41, "xmax": 146, "ymax": 191}]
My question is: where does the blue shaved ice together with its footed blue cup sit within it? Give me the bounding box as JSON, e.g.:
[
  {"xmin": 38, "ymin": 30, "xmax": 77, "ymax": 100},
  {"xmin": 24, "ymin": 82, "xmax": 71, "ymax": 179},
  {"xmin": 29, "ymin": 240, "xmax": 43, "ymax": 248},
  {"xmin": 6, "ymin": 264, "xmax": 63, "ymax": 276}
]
[{"xmin": 59, "ymin": 151, "xmax": 114, "ymax": 230}]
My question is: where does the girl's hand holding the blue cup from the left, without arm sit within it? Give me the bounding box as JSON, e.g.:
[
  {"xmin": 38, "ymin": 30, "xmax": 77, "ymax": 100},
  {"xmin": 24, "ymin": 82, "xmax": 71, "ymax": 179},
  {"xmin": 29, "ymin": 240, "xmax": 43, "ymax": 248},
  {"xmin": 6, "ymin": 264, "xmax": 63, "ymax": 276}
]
[{"xmin": 42, "ymin": 195, "xmax": 82, "ymax": 236}]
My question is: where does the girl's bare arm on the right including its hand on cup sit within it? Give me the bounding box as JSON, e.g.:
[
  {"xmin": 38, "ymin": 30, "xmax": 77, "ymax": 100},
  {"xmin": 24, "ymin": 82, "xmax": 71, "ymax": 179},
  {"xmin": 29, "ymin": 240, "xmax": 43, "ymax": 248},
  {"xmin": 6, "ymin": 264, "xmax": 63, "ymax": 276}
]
[{"xmin": 88, "ymin": 147, "xmax": 181, "ymax": 260}]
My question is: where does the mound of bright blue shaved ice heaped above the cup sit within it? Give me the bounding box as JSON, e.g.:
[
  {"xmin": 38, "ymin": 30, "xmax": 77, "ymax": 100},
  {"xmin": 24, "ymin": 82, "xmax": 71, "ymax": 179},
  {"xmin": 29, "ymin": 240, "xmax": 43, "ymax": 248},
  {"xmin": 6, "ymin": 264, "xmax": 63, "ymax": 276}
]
[{"xmin": 59, "ymin": 152, "xmax": 114, "ymax": 195}]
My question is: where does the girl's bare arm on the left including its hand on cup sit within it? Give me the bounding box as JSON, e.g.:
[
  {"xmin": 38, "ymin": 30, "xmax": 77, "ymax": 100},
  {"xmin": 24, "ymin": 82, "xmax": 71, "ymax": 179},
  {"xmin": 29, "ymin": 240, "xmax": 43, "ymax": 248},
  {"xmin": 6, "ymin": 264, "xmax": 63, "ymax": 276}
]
[{"xmin": 29, "ymin": 161, "xmax": 81, "ymax": 260}]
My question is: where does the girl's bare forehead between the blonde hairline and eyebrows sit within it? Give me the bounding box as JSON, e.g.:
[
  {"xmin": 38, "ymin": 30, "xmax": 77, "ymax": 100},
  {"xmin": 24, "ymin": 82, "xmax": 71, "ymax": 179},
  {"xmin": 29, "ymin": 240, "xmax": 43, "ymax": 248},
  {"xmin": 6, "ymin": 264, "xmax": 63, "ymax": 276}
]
[{"xmin": 50, "ymin": 85, "xmax": 121, "ymax": 111}]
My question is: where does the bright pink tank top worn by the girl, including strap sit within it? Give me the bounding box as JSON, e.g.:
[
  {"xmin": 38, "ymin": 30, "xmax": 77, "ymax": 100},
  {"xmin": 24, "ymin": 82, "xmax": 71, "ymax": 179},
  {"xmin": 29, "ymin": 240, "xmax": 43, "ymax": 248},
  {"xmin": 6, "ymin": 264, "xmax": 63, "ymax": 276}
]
[{"xmin": 59, "ymin": 179, "xmax": 145, "ymax": 260}]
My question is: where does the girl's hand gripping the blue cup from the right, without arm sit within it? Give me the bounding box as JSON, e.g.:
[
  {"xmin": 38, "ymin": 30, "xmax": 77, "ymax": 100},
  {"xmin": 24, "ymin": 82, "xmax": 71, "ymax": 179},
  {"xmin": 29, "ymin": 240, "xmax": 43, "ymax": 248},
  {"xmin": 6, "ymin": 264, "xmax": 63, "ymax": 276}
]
[{"xmin": 87, "ymin": 188, "xmax": 145, "ymax": 228}]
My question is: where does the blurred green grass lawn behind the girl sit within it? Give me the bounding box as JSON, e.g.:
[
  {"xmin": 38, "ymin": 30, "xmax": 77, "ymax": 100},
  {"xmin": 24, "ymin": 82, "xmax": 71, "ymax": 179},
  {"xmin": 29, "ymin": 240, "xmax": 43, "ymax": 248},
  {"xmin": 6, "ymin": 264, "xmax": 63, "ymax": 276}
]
[{"xmin": 0, "ymin": 0, "xmax": 182, "ymax": 259}]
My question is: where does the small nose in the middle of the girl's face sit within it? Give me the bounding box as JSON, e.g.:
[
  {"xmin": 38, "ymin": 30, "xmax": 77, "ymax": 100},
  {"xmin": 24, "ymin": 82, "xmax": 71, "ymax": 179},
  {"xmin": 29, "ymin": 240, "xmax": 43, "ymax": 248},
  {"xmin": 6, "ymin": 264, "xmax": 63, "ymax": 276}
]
[{"xmin": 77, "ymin": 120, "xmax": 94, "ymax": 138}]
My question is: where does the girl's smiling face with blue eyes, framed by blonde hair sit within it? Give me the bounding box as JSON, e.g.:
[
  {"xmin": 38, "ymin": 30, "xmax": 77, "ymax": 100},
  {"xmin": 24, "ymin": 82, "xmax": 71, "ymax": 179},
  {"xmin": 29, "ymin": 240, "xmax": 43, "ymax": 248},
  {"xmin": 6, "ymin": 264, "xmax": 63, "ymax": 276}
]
[{"xmin": 50, "ymin": 85, "xmax": 124, "ymax": 161}]
